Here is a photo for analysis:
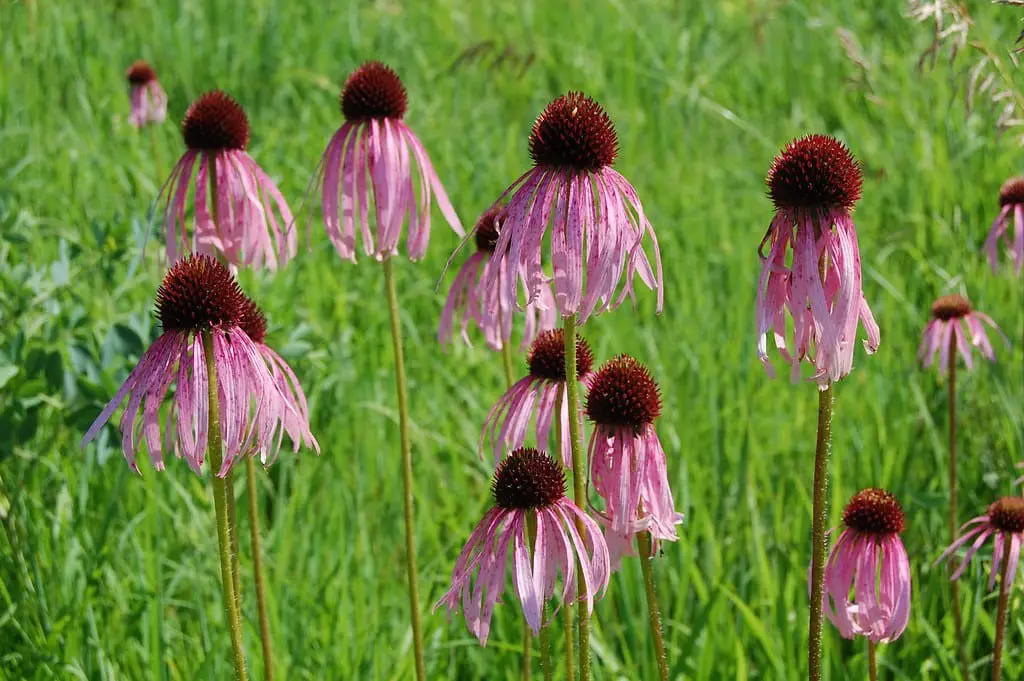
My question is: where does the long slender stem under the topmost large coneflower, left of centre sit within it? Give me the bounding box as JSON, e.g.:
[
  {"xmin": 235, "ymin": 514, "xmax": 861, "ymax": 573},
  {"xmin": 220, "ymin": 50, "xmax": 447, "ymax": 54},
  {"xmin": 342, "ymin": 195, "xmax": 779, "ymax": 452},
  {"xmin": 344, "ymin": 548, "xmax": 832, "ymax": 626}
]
[{"xmin": 382, "ymin": 257, "xmax": 427, "ymax": 681}]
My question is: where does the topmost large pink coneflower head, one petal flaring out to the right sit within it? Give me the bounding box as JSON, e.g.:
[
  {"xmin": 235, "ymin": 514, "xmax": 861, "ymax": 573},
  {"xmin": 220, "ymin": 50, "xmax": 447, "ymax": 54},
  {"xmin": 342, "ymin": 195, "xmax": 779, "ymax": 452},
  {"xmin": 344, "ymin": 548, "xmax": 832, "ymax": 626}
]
[{"xmin": 315, "ymin": 61, "xmax": 463, "ymax": 262}]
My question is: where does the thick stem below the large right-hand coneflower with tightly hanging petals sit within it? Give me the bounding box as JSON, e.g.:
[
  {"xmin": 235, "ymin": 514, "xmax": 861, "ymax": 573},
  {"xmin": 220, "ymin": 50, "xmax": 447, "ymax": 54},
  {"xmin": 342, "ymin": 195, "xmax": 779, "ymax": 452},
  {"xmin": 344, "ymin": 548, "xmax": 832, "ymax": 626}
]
[{"xmin": 807, "ymin": 384, "xmax": 833, "ymax": 681}]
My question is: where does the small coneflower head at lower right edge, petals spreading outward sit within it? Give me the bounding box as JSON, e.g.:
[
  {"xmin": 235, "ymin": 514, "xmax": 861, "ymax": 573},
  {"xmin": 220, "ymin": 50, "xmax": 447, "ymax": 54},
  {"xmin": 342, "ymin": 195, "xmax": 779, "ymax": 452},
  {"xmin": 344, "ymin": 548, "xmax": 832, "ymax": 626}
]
[{"xmin": 937, "ymin": 497, "xmax": 1024, "ymax": 591}]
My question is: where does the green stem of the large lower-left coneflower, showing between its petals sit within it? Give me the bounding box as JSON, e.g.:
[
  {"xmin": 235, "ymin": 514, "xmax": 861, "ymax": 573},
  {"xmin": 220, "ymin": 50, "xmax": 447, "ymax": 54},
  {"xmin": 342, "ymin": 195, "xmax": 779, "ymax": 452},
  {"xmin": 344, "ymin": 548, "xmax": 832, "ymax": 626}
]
[{"xmin": 203, "ymin": 331, "xmax": 248, "ymax": 681}]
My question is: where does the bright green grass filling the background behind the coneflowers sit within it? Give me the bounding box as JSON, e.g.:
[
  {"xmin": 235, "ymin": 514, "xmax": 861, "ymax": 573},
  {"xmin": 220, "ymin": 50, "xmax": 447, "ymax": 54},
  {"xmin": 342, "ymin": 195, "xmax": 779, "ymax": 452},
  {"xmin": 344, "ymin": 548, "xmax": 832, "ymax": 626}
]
[{"xmin": 0, "ymin": 0, "xmax": 1024, "ymax": 681}]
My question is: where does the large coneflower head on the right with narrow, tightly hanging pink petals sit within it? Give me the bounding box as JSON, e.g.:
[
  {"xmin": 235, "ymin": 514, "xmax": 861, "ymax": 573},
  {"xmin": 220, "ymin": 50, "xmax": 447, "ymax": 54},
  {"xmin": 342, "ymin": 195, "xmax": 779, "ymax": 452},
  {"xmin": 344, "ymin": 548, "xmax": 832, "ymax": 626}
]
[{"xmin": 757, "ymin": 135, "xmax": 880, "ymax": 390}]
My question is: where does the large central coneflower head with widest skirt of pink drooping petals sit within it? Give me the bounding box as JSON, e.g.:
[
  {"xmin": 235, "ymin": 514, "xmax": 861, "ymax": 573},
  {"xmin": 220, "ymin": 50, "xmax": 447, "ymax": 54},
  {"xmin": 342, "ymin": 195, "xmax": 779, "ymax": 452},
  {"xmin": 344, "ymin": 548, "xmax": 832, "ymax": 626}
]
[{"xmin": 485, "ymin": 92, "xmax": 665, "ymax": 324}]
